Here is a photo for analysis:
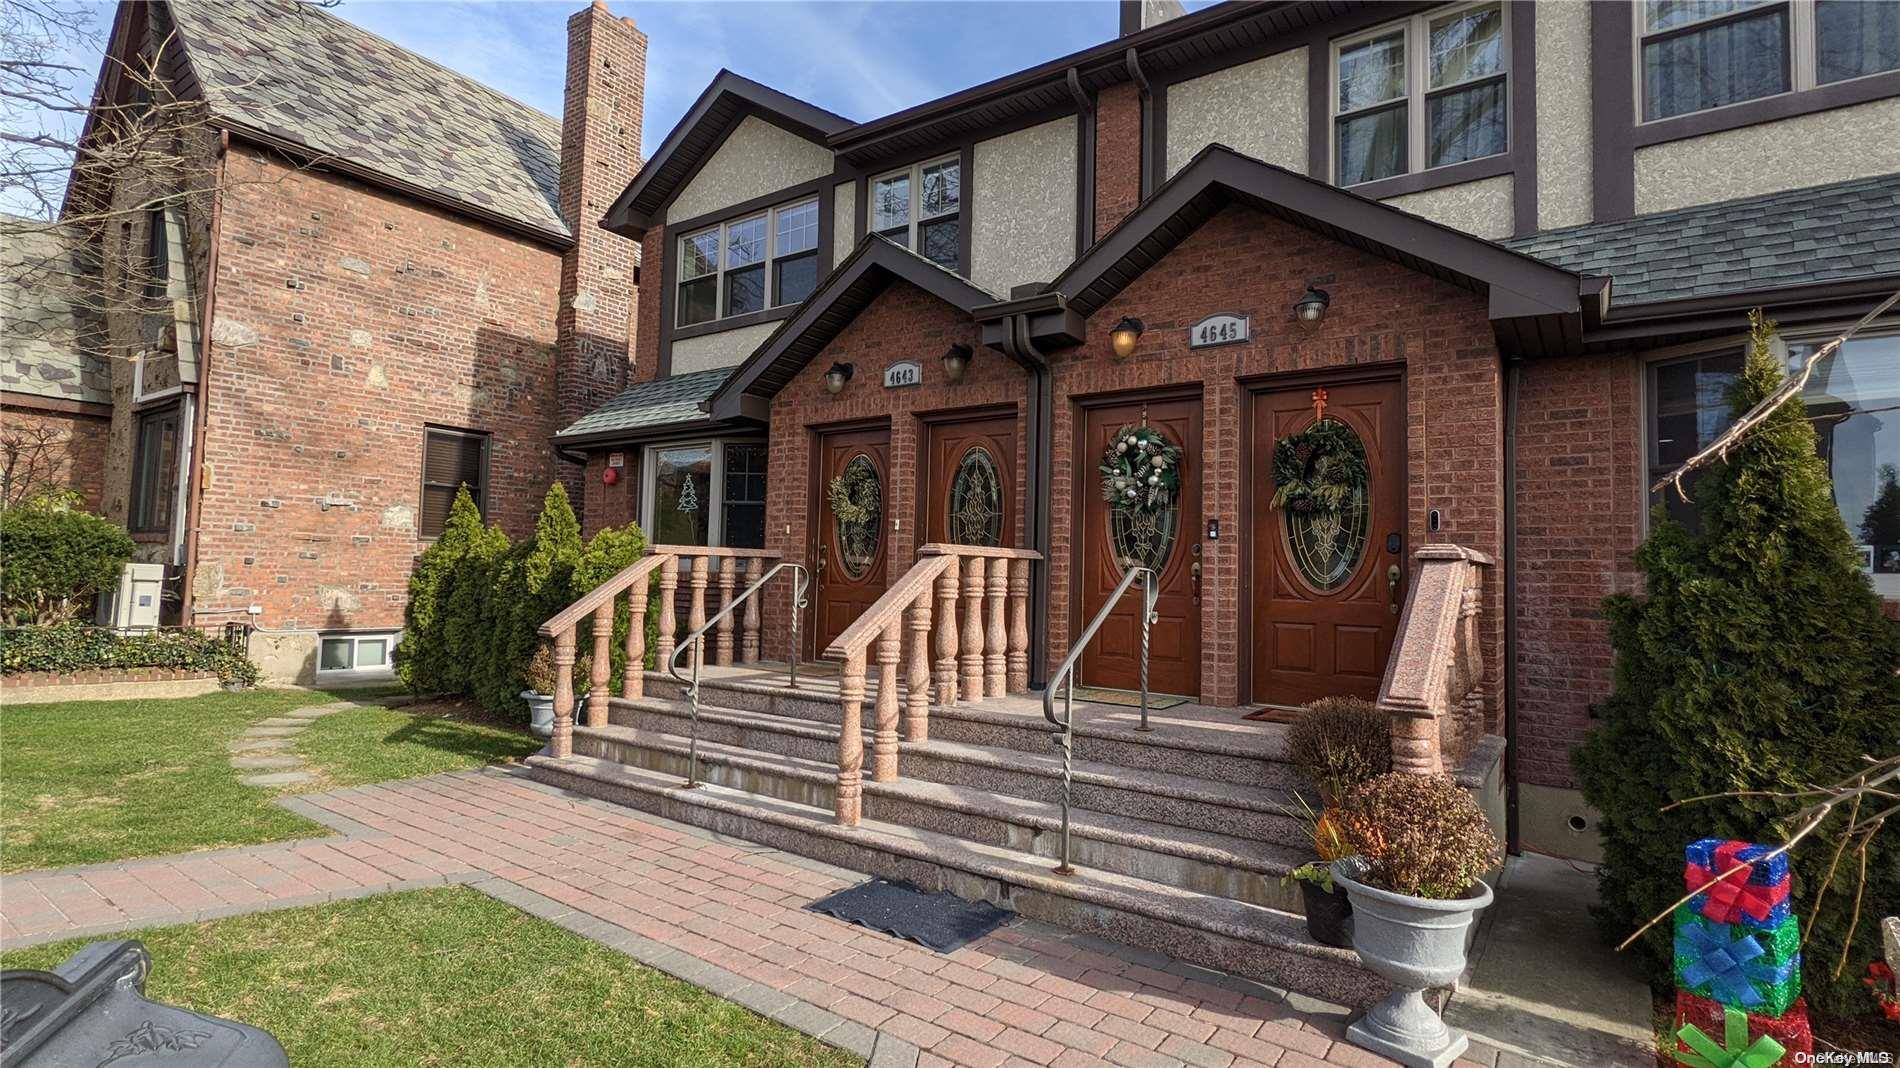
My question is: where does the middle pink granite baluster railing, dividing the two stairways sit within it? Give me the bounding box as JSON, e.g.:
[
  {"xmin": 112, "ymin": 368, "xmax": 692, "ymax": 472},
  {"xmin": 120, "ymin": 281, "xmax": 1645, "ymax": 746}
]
[{"xmin": 825, "ymin": 544, "xmax": 1043, "ymax": 827}]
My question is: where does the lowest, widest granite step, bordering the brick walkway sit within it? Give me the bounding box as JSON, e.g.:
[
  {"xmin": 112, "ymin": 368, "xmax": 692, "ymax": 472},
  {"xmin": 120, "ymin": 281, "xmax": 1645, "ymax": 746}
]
[{"xmin": 528, "ymin": 748, "xmax": 1385, "ymax": 1005}]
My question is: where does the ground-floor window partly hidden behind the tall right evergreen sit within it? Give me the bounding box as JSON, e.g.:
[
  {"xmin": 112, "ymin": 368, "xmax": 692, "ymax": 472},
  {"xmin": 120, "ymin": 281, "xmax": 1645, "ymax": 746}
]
[{"xmin": 1647, "ymin": 333, "xmax": 1900, "ymax": 597}]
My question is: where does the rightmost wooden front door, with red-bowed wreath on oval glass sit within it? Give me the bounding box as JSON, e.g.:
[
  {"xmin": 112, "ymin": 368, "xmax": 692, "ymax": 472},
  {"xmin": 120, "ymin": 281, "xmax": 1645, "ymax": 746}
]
[{"xmin": 1252, "ymin": 380, "xmax": 1406, "ymax": 707}]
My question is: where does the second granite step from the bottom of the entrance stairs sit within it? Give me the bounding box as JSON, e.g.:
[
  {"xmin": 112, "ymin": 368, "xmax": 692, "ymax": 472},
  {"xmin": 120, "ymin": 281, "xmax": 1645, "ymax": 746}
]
[{"xmin": 574, "ymin": 711, "xmax": 1309, "ymax": 896}]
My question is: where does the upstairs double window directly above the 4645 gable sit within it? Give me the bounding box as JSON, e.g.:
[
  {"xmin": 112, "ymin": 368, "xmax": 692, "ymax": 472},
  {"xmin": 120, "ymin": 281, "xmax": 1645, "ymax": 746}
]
[{"xmin": 1332, "ymin": 2, "xmax": 1511, "ymax": 186}]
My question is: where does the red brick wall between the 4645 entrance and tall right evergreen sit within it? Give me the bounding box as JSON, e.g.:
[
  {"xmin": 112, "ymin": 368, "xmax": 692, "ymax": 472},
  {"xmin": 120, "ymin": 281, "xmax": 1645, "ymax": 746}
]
[{"xmin": 1516, "ymin": 355, "xmax": 1644, "ymax": 787}]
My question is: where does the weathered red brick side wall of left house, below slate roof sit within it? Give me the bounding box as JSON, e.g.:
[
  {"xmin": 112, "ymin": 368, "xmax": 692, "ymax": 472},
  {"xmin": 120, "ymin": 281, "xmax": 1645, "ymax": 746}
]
[{"xmin": 194, "ymin": 143, "xmax": 561, "ymax": 629}]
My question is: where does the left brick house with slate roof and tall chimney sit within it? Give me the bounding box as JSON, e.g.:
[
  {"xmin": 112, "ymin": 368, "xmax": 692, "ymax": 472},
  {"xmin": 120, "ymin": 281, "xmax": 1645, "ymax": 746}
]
[{"xmin": 33, "ymin": 0, "xmax": 646, "ymax": 682}]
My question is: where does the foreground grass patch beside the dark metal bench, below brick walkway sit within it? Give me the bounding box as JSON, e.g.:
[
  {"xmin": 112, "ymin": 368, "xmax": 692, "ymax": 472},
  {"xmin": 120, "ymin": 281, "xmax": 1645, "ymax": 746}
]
[{"xmin": 0, "ymin": 887, "xmax": 859, "ymax": 1068}]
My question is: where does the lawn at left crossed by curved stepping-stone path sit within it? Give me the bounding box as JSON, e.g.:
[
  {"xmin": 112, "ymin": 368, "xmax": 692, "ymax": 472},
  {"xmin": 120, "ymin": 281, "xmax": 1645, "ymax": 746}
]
[{"xmin": 0, "ymin": 690, "xmax": 540, "ymax": 872}]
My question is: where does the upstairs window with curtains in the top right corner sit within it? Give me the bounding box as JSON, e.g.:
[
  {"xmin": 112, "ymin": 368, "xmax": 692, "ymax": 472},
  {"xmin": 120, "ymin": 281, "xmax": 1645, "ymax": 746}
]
[{"xmin": 1636, "ymin": 0, "xmax": 1900, "ymax": 122}]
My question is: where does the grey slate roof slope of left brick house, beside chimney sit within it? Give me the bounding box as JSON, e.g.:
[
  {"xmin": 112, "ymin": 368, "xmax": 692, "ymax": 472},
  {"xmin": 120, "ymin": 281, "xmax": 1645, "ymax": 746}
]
[{"xmin": 171, "ymin": 0, "xmax": 572, "ymax": 238}]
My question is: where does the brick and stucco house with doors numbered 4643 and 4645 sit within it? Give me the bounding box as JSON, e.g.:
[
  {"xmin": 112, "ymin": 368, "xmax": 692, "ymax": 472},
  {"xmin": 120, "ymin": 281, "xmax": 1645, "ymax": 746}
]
[{"xmin": 557, "ymin": 0, "xmax": 1900, "ymax": 855}]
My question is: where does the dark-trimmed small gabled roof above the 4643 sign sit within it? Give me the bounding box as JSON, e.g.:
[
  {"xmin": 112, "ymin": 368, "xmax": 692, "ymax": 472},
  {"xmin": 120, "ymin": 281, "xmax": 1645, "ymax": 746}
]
[{"xmin": 709, "ymin": 234, "xmax": 998, "ymax": 422}]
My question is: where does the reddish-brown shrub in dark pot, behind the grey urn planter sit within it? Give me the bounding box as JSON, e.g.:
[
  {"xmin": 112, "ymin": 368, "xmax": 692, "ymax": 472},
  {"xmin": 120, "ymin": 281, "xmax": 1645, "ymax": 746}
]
[{"xmin": 1284, "ymin": 697, "xmax": 1393, "ymax": 948}]
